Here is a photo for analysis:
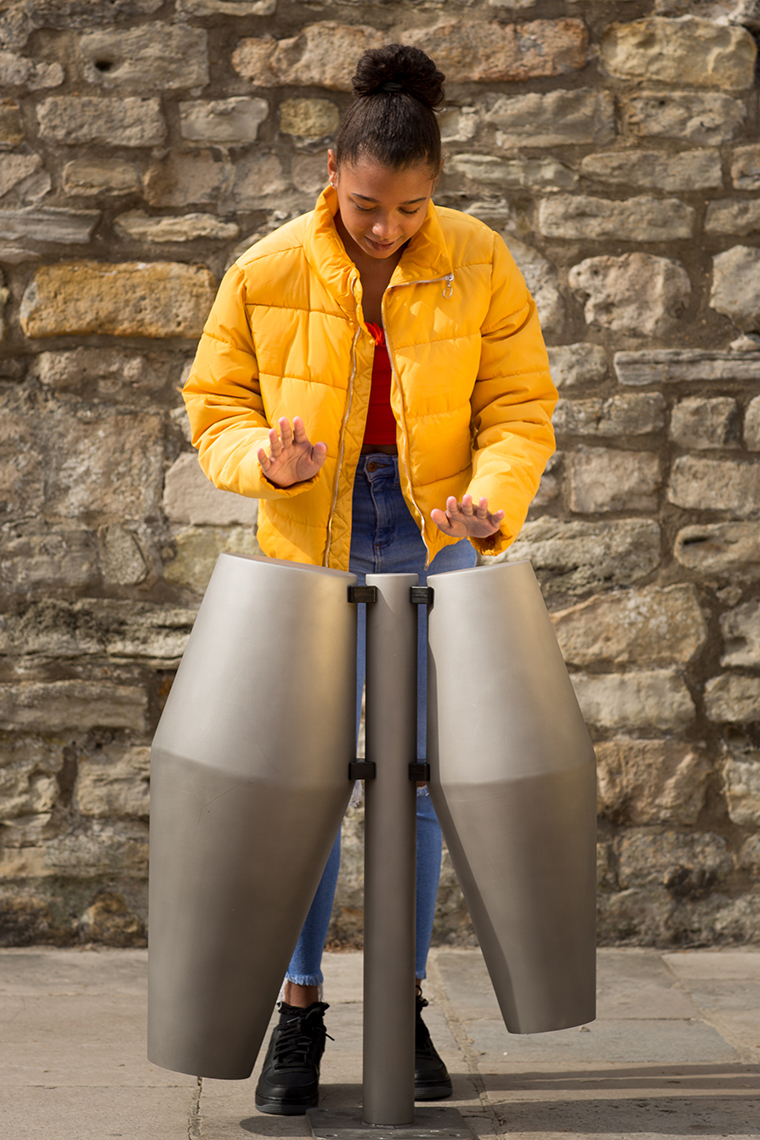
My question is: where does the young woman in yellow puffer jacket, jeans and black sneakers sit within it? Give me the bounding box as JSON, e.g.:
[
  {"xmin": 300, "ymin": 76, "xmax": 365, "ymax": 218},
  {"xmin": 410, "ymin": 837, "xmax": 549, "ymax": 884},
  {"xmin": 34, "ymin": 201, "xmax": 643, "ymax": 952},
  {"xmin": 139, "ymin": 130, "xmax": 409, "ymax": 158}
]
[{"xmin": 185, "ymin": 44, "xmax": 556, "ymax": 1115}]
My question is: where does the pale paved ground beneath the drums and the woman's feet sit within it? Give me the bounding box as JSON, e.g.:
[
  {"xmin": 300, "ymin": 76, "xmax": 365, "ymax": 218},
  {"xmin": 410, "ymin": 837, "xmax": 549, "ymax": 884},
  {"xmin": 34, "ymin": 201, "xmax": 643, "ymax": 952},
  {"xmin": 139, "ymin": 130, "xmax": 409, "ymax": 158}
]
[{"xmin": 0, "ymin": 947, "xmax": 760, "ymax": 1140}]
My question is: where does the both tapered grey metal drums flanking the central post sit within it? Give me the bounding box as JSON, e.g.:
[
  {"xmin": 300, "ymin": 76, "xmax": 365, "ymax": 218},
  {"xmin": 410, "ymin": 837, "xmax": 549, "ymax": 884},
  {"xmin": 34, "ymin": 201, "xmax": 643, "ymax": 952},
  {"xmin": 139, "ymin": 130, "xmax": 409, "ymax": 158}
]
[{"xmin": 148, "ymin": 554, "xmax": 596, "ymax": 1080}]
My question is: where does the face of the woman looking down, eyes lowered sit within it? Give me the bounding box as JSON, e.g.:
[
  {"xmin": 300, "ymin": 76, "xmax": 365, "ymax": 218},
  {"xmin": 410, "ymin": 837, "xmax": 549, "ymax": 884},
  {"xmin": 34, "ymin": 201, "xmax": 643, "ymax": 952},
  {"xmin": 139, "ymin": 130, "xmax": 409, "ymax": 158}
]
[{"xmin": 327, "ymin": 150, "xmax": 436, "ymax": 259}]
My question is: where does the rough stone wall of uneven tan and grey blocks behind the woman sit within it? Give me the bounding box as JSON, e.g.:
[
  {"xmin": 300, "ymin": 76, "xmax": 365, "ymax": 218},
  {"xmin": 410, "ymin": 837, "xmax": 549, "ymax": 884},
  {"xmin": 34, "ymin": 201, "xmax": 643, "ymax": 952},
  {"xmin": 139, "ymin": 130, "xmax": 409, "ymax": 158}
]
[{"xmin": 0, "ymin": 0, "xmax": 760, "ymax": 945}]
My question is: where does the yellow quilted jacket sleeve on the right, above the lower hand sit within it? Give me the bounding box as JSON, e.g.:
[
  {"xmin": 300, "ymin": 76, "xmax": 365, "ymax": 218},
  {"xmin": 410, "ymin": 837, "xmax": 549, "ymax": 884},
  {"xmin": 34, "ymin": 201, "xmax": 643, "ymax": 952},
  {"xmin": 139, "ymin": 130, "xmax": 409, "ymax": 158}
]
[{"xmin": 468, "ymin": 234, "xmax": 557, "ymax": 554}]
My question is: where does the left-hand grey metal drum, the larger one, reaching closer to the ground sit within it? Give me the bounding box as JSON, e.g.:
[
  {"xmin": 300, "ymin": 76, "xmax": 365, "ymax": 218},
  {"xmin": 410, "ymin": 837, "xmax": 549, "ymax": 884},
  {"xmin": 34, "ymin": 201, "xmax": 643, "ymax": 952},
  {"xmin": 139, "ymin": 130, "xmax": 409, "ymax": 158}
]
[{"xmin": 148, "ymin": 554, "xmax": 357, "ymax": 1078}]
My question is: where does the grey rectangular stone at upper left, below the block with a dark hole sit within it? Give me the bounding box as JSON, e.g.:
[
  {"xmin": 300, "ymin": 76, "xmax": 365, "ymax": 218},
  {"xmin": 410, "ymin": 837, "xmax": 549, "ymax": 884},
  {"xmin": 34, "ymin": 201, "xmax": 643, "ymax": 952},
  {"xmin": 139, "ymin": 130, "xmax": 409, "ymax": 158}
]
[{"xmin": 36, "ymin": 95, "xmax": 166, "ymax": 146}]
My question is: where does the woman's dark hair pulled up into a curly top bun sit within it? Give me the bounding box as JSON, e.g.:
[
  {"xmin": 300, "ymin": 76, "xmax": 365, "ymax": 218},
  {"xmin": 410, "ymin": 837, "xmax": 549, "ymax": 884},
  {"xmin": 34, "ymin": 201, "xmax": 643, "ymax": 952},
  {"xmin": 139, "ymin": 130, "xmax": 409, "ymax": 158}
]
[{"xmin": 335, "ymin": 43, "xmax": 446, "ymax": 176}]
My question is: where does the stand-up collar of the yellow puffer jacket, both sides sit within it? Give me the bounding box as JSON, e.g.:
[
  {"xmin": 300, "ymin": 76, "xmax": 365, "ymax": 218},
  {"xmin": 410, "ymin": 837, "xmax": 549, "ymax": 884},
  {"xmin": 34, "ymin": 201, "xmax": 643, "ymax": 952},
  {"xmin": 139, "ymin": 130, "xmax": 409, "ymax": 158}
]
[{"xmin": 303, "ymin": 186, "xmax": 451, "ymax": 312}]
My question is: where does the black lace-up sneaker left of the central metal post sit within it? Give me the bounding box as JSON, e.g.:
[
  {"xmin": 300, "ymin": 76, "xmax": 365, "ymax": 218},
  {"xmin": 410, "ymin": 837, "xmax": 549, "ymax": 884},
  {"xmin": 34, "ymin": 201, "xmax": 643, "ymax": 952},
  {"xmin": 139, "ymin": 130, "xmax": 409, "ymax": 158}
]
[{"xmin": 256, "ymin": 1001, "xmax": 329, "ymax": 1116}]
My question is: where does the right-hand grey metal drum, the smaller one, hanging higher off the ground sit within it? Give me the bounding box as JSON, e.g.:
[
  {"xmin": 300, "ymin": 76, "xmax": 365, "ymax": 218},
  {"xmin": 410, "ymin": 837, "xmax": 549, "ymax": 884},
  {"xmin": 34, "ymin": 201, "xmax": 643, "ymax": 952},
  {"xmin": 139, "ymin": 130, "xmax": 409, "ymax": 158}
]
[{"xmin": 427, "ymin": 562, "xmax": 596, "ymax": 1033}]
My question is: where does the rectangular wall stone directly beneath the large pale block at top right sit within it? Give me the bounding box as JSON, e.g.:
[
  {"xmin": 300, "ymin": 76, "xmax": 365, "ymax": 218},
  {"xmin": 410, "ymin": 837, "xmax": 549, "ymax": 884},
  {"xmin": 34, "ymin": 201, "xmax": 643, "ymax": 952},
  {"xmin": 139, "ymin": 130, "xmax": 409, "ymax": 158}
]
[{"xmin": 621, "ymin": 91, "xmax": 746, "ymax": 146}]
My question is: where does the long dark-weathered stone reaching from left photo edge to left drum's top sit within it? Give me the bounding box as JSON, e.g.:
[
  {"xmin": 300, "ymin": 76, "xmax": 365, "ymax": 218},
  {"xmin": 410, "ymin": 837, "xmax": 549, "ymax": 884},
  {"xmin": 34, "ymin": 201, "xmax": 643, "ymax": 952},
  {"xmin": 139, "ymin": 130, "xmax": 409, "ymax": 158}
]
[{"xmin": 0, "ymin": 597, "xmax": 196, "ymax": 661}]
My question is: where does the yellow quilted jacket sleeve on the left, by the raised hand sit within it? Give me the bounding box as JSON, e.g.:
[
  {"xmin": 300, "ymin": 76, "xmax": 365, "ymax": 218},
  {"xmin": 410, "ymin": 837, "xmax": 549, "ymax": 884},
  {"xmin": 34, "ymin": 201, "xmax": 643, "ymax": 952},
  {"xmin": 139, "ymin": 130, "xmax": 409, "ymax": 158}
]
[{"xmin": 182, "ymin": 264, "xmax": 318, "ymax": 499}]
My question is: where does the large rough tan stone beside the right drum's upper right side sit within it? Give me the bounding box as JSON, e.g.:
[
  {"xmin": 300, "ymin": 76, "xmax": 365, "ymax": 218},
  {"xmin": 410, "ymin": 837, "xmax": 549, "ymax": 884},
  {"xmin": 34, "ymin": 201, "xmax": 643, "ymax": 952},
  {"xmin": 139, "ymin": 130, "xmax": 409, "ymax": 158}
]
[{"xmin": 551, "ymin": 585, "xmax": 708, "ymax": 666}]
